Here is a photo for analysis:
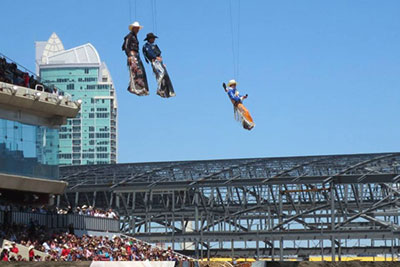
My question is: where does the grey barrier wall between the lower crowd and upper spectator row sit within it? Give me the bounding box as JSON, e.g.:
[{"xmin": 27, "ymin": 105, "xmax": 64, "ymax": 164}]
[{"xmin": 0, "ymin": 211, "xmax": 119, "ymax": 232}]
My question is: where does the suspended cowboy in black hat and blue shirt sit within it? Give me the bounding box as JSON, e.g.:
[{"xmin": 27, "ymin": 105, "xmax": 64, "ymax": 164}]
[{"xmin": 143, "ymin": 32, "xmax": 175, "ymax": 97}]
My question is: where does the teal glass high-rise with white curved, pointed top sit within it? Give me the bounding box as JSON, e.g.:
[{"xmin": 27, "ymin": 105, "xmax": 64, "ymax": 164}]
[{"xmin": 35, "ymin": 33, "xmax": 117, "ymax": 165}]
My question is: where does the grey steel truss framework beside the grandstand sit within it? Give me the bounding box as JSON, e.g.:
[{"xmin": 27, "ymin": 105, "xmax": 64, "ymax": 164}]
[{"xmin": 59, "ymin": 153, "xmax": 400, "ymax": 259}]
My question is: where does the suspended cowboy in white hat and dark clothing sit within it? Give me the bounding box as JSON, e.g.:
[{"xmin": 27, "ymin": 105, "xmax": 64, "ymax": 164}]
[{"xmin": 122, "ymin": 21, "xmax": 149, "ymax": 96}]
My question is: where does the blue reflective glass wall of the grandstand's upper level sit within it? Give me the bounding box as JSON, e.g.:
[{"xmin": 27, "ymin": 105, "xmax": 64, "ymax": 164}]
[{"xmin": 0, "ymin": 119, "xmax": 59, "ymax": 180}]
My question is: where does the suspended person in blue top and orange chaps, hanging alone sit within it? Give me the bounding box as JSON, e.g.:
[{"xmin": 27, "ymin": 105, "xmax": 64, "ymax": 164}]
[{"xmin": 222, "ymin": 80, "xmax": 255, "ymax": 130}]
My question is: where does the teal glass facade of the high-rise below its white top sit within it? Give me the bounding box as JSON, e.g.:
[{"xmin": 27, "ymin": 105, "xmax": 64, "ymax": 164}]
[{"xmin": 40, "ymin": 65, "xmax": 117, "ymax": 165}]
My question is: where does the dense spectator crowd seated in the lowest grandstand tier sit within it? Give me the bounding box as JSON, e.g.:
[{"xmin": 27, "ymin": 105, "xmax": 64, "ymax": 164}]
[{"xmin": 0, "ymin": 223, "xmax": 189, "ymax": 261}]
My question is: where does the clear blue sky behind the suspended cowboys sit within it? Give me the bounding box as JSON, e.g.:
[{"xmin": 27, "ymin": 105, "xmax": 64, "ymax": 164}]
[{"xmin": 0, "ymin": 0, "xmax": 400, "ymax": 162}]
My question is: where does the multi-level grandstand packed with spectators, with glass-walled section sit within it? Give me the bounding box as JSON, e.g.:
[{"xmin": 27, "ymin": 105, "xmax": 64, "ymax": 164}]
[{"xmin": 0, "ymin": 54, "xmax": 189, "ymax": 266}]
